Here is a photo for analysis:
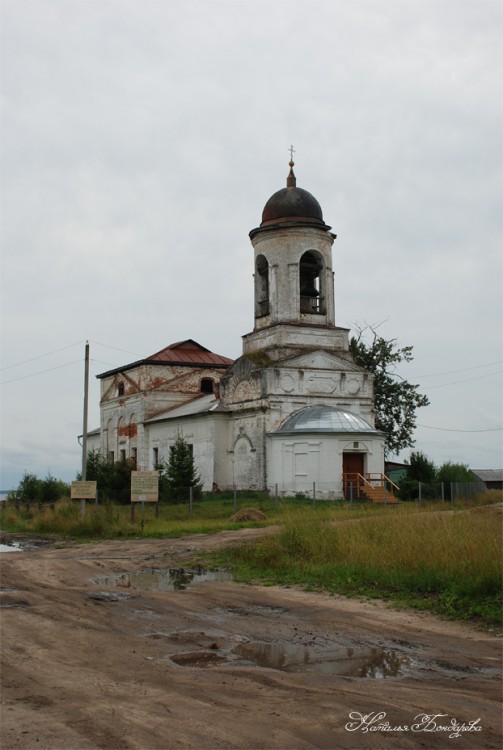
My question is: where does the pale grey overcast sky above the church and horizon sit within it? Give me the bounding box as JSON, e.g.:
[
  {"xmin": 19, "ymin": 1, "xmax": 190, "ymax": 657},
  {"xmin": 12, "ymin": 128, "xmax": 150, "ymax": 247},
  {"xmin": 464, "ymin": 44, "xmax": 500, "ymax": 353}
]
[{"xmin": 0, "ymin": 0, "xmax": 503, "ymax": 489}]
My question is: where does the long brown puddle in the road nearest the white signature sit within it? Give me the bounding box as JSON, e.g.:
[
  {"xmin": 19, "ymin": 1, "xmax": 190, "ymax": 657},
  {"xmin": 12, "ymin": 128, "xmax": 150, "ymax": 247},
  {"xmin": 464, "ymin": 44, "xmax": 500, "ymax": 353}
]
[{"xmin": 234, "ymin": 641, "xmax": 411, "ymax": 680}]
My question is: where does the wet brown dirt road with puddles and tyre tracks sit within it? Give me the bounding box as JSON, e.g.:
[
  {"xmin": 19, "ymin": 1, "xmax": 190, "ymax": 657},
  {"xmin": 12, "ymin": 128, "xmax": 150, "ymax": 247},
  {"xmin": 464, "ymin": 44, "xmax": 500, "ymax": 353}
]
[{"xmin": 1, "ymin": 530, "xmax": 502, "ymax": 750}]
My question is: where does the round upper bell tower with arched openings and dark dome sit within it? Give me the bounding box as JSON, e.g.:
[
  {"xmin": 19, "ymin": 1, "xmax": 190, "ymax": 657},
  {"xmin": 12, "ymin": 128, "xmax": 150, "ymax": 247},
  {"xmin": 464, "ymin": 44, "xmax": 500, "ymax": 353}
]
[{"xmin": 243, "ymin": 159, "xmax": 347, "ymax": 360}]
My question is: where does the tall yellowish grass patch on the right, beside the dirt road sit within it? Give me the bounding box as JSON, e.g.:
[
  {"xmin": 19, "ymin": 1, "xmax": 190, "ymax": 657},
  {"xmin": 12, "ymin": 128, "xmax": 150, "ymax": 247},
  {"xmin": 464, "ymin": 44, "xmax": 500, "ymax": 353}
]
[{"xmin": 225, "ymin": 506, "xmax": 502, "ymax": 624}]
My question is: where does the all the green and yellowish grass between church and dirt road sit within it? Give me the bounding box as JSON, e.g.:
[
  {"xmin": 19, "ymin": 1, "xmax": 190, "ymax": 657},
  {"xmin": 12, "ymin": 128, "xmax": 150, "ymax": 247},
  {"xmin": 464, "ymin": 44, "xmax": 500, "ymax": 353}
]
[{"xmin": 0, "ymin": 492, "xmax": 503, "ymax": 627}]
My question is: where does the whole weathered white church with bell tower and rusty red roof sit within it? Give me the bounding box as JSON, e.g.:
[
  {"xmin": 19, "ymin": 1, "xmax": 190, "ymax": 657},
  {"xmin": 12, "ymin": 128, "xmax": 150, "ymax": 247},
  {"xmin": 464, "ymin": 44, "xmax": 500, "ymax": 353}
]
[{"xmin": 88, "ymin": 161, "xmax": 385, "ymax": 497}]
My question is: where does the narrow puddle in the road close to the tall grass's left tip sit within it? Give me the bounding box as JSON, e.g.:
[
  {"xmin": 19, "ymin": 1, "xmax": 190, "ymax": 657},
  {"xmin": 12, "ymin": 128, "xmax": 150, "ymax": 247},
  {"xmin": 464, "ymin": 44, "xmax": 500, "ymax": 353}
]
[{"xmin": 92, "ymin": 568, "xmax": 232, "ymax": 591}]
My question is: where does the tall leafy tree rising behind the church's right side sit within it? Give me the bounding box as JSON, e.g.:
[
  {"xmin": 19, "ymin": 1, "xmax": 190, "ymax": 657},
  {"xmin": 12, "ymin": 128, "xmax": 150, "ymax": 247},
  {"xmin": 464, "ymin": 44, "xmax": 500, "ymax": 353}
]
[{"xmin": 349, "ymin": 326, "xmax": 430, "ymax": 453}]
